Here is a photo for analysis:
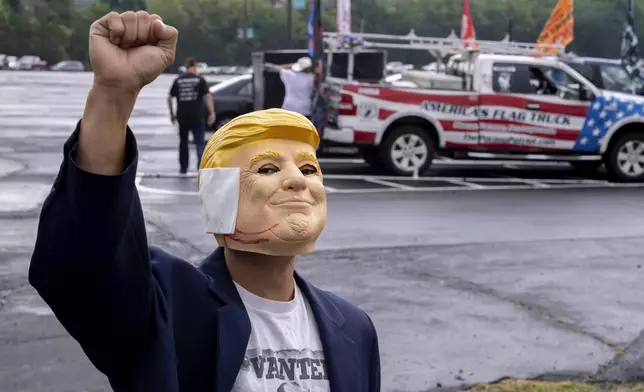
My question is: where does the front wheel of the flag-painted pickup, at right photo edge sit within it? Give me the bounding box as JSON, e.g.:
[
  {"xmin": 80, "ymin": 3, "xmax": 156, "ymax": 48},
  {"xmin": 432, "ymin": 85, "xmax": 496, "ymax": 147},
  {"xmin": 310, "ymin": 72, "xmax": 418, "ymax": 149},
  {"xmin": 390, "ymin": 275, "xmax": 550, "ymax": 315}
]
[{"xmin": 605, "ymin": 133, "xmax": 644, "ymax": 182}]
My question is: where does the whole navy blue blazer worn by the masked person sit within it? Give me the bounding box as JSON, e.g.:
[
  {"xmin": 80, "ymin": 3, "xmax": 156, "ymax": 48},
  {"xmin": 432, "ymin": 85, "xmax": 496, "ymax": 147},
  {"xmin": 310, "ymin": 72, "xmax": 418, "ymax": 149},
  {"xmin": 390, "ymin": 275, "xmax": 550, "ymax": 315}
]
[{"xmin": 29, "ymin": 123, "xmax": 380, "ymax": 392}]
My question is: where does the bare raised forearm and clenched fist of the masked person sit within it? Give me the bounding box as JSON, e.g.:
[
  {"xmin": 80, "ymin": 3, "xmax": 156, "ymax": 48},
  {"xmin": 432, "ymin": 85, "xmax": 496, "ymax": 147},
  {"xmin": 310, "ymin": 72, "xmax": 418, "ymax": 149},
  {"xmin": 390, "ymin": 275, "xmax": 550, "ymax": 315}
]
[{"xmin": 76, "ymin": 11, "xmax": 178, "ymax": 175}]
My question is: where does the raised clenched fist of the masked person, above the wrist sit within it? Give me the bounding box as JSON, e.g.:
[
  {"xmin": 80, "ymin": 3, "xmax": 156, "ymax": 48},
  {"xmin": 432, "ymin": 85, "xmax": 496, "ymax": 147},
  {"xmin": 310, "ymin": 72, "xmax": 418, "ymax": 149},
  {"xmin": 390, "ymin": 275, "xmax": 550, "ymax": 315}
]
[{"xmin": 89, "ymin": 11, "xmax": 178, "ymax": 92}]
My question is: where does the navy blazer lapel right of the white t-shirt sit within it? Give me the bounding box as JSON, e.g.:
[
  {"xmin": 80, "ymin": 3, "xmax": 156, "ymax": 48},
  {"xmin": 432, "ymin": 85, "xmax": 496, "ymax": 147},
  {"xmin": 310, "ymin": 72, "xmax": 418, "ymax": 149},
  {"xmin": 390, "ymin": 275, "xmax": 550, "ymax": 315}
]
[{"xmin": 295, "ymin": 273, "xmax": 365, "ymax": 392}]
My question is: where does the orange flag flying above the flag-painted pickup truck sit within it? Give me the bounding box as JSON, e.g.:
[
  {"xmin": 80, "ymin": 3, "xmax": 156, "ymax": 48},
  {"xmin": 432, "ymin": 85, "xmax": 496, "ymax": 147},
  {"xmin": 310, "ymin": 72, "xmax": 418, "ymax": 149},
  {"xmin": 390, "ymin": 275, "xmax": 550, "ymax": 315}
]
[{"xmin": 537, "ymin": 0, "xmax": 575, "ymax": 53}]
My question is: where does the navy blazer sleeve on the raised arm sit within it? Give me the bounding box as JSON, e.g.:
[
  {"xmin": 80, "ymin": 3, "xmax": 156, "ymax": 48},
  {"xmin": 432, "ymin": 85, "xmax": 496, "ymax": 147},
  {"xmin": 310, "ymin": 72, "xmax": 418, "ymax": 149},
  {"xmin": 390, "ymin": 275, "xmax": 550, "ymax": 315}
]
[{"xmin": 29, "ymin": 122, "xmax": 166, "ymax": 376}]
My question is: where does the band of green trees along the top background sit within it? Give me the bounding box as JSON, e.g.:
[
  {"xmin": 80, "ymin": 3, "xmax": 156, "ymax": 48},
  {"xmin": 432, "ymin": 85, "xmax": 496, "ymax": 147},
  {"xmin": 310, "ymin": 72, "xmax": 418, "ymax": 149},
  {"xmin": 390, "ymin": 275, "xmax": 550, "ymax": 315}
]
[{"xmin": 0, "ymin": 0, "xmax": 644, "ymax": 66}]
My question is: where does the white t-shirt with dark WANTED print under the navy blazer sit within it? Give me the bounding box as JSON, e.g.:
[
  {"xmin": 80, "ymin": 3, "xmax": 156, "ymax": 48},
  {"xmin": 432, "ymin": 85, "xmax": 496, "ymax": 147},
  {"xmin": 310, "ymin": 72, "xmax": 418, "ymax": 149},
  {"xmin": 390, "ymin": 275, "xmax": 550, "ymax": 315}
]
[{"xmin": 232, "ymin": 283, "xmax": 330, "ymax": 392}]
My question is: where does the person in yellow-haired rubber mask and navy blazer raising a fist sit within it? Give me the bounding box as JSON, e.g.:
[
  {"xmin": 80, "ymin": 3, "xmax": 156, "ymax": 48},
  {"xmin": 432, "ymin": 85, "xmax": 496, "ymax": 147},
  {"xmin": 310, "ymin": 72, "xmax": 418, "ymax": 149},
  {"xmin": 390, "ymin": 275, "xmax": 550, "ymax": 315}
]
[{"xmin": 29, "ymin": 11, "xmax": 380, "ymax": 392}]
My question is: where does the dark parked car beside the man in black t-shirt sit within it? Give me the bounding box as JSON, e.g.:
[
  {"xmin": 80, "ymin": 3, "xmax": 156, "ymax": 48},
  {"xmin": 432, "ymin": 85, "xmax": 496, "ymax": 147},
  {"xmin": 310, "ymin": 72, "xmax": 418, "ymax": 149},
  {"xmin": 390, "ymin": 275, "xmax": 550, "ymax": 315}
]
[{"xmin": 210, "ymin": 74, "xmax": 253, "ymax": 131}]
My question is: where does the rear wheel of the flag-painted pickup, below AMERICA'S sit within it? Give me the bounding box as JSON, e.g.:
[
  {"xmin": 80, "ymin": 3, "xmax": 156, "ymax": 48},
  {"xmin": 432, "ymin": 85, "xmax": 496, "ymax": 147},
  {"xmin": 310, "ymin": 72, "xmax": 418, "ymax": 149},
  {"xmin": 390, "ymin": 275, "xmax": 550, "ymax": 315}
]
[{"xmin": 380, "ymin": 125, "xmax": 435, "ymax": 176}]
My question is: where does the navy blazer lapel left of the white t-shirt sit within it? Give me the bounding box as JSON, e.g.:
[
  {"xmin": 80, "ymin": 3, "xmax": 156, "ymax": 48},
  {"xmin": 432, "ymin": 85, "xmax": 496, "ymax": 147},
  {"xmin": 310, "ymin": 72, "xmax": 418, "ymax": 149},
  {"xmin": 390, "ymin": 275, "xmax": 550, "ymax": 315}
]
[{"xmin": 200, "ymin": 248, "xmax": 251, "ymax": 392}]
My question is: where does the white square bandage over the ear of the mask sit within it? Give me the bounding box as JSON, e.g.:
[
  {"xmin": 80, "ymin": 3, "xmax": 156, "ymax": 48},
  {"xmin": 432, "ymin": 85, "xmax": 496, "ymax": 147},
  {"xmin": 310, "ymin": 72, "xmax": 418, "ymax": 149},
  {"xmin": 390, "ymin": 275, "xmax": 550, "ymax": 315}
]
[{"xmin": 199, "ymin": 168, "xmax": 239, "ymax": 234}]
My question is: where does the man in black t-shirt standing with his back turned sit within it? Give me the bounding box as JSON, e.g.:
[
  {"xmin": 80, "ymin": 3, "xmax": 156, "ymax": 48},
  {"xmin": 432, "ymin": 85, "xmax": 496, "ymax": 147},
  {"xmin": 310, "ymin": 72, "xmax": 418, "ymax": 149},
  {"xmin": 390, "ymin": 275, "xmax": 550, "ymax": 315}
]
[{"xmin": 168, "ymin": 59, "xmax": 215, "ymax": 174}]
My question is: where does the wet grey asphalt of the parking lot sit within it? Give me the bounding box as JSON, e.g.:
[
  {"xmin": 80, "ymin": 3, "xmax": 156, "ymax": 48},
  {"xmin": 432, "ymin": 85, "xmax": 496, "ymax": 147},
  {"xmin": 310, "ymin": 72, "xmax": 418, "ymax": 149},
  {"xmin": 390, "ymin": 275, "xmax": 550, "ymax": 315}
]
[{"xmin": 0, "ymin": 72, "xmax": 644, "ymax": 392}]
